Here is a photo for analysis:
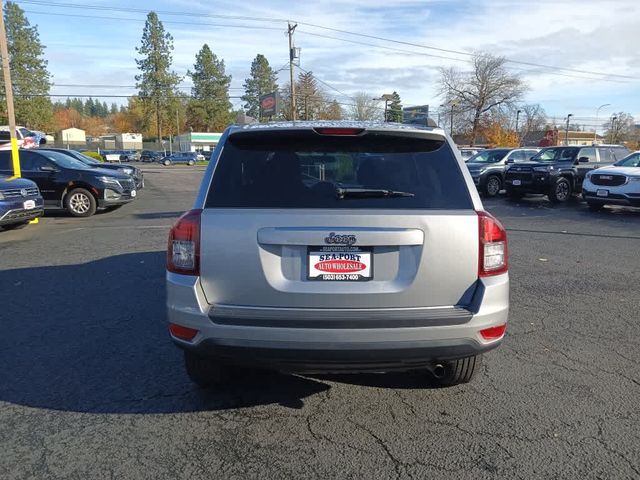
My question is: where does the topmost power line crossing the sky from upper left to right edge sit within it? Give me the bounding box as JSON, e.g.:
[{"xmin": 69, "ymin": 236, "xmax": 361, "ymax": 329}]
[{"xmin": 19, "ymin": 0, "xmax": 637, "ymax": 81}]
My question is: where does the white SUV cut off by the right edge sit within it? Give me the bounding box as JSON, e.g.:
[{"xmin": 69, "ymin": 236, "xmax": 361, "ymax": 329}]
[{"xmin": 582, "ymin": 151, "xmax": 640, "ymax": 210}]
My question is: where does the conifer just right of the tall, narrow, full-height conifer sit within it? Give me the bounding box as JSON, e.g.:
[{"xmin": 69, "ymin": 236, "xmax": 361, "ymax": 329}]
[{"xmin": 187, "ymin": 43, "xmax": 233, "ymax": 132}]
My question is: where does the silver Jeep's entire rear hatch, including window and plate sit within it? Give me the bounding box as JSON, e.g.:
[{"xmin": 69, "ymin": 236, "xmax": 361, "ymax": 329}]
[{"xmin": 200, "ymin": 125, "xmax": 478, "ymax": 309}]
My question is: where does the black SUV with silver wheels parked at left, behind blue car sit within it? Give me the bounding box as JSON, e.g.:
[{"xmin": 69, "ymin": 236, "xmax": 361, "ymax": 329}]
[{"xmin": 0, "ymin": 149, "xmax": 137, "ymax": 217}]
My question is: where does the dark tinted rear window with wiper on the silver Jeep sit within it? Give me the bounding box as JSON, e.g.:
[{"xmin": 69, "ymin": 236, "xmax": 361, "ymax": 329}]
[{"xmin": 206, "ymin": 130, "xmax": 473, "ymax": 209}]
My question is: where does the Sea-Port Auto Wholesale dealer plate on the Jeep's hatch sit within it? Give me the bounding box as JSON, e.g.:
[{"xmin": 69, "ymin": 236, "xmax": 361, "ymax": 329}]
[{"xmin": 307, "ymin": 246, "xmax": 373, "ymax": 282}]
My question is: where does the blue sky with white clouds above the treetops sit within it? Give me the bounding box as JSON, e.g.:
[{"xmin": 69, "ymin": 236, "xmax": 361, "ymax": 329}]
[{"xmin": 17, "ymin": 0, "xmax": 640, "ymax": 129}]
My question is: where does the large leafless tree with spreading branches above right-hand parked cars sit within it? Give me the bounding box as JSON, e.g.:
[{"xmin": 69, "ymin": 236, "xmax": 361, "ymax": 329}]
[{"xmin": 440, "ymin": 54, "xmax": 527, "ymax": 145}]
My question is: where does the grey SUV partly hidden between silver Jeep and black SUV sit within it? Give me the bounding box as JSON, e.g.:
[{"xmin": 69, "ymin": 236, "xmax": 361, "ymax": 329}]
[{"xmin": 467, "ymin": 148, "xmax": 538, "ymax": 197}]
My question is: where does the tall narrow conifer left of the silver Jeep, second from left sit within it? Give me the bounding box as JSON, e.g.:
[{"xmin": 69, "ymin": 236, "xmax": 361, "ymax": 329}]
[{"xmin": 136, "ymin": 12, "xmax": 180, "ymax": 142}]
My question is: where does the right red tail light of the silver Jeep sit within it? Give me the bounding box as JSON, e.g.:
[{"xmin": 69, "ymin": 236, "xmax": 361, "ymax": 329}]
[{"xmin": 478, "ymin": 211, "xmax": 509, "ymax": 277}]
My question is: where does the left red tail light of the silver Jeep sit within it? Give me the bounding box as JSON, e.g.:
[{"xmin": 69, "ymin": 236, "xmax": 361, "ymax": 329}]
[{"xmin": 167, "ymin": 209, "xmax": 202, "ymax": 275}]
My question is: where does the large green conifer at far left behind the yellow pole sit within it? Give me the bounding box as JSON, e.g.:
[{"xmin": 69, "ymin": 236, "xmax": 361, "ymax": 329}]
[{"xmin": 0, "ymin": 2, "xmax": 53, "ymax": 130}]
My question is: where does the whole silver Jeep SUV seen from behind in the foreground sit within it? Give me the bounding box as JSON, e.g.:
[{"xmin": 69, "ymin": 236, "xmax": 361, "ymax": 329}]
[{"xmin": 167, "ymin": 122, "xmax": 509, "ymax": 386}]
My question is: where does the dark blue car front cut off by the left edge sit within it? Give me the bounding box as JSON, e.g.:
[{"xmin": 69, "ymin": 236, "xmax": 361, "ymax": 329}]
[{"xmin": 0, "ymin": 176, "xmax": 44, "ymax": 229}]
